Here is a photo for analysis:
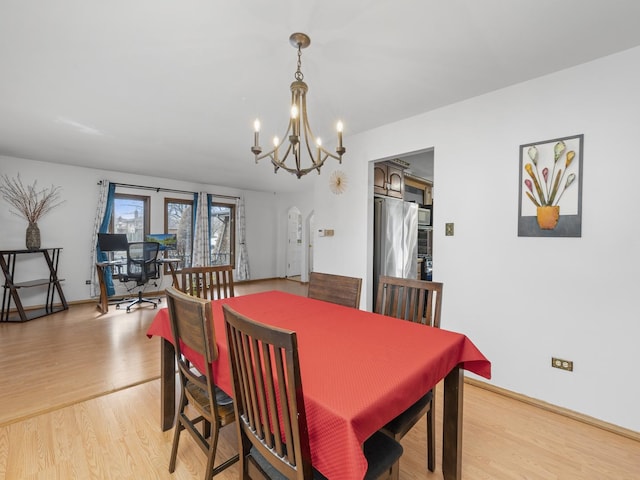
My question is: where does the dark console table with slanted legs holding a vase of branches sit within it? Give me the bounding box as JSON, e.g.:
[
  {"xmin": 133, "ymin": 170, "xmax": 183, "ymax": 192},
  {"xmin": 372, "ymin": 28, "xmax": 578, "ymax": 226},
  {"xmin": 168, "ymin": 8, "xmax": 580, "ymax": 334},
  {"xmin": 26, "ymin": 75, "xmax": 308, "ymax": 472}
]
[{"xmin": 0, "ymin": 248, "xmax": 69, "ymax": 322}]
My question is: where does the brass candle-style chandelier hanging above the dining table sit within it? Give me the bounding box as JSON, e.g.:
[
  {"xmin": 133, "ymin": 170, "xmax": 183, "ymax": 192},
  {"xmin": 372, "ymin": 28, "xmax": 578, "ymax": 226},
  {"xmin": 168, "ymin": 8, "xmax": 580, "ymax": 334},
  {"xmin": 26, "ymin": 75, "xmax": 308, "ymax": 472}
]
[{"xmin": 251, "ymin": 33, "xmax": 346, "ymax": 178}]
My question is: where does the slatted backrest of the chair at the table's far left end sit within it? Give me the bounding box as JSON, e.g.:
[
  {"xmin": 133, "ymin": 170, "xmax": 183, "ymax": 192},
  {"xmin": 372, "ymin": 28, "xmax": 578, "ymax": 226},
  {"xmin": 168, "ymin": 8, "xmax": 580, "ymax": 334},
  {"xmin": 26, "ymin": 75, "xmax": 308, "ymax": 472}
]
[{"xmin": 178, "ymin": 265, "xmax": 235, "ymax": 300}]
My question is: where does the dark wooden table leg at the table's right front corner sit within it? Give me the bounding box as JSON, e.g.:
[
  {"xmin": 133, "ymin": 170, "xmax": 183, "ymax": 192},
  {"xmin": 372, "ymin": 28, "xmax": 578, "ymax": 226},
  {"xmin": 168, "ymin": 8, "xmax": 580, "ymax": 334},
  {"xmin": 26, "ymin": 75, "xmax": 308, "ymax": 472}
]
[{"xmin": 442, "ymin": 366, "xmax": 464, "ymax": 480}]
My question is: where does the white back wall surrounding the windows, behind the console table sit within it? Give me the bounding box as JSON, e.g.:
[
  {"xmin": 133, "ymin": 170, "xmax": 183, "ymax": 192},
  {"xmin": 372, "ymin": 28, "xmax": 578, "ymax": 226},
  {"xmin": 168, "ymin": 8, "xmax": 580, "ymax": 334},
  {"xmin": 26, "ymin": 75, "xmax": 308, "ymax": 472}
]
[{"xmin": 0, "ymin": 156, "xmax": 296, "ymax": 306}]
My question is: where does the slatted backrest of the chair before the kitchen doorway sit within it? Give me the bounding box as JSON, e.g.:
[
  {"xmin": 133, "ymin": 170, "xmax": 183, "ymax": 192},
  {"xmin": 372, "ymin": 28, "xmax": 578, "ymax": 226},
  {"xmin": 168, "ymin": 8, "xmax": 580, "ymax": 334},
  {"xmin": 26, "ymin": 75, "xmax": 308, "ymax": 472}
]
[{"xmin": 374, "ymin": 276, "xmax": 443, "ymax": 328}]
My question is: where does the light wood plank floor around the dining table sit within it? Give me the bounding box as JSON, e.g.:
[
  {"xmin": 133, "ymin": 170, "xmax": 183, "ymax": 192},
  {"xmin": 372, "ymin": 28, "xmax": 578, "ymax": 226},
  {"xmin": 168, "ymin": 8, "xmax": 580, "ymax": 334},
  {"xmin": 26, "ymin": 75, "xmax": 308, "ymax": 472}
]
[{"xmin": 0, "ymin": 280, "xmax": 640, "ymax": 480}]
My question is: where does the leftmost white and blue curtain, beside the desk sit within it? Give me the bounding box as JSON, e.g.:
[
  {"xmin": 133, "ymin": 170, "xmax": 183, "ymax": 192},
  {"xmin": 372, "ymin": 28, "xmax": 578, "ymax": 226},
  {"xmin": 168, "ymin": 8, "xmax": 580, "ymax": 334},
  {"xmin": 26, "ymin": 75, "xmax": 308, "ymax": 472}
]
[{"xmin": 89, "ymin": 180, "xmax": 116, "ymax": 297}]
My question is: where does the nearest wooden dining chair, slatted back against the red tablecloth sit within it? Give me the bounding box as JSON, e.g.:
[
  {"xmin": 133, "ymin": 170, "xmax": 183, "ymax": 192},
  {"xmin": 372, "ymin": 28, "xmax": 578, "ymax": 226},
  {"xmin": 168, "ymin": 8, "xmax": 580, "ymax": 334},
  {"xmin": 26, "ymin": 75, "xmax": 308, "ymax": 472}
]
[{"xmin": 223, "ymin": 305, "xmax": 402, "ymax": 480}]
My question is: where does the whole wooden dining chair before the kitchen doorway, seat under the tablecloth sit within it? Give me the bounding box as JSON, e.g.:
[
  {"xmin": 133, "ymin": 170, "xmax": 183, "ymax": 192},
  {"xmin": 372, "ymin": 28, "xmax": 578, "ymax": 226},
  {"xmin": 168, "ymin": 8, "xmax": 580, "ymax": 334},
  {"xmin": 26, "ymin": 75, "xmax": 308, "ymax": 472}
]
[{"xmin": 374, "ymin": 276, "xmax": 443, "ymax": 479}]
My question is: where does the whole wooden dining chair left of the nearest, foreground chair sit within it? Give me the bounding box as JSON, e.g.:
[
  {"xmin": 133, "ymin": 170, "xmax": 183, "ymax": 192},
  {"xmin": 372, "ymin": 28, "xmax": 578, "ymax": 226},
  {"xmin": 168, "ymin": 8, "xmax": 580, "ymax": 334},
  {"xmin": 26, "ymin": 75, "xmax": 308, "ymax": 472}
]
[{"xmin": 166, "ymin": 287, "xmax": 239, "ymax": 480}]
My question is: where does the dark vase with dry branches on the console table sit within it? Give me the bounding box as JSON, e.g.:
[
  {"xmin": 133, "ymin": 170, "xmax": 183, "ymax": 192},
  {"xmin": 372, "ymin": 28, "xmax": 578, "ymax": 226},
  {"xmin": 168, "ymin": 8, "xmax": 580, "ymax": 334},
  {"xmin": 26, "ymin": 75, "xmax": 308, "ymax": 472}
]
[{"xmin": 0, "ymin": 174, "xmax": 63, "ymax": 250}]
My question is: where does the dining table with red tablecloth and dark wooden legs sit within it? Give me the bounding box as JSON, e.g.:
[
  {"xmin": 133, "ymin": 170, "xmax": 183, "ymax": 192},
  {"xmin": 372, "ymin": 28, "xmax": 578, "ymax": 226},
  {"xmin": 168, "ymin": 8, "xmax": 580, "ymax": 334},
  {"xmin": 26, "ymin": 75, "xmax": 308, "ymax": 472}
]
[{"xmin": 147, "ymin": 291, "xmax": 491, "ymax": 480}]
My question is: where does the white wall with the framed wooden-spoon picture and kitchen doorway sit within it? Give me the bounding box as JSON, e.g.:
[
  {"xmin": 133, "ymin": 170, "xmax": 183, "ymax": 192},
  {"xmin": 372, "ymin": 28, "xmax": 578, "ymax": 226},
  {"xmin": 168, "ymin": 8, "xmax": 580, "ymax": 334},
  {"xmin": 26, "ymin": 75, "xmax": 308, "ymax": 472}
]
[{"xmin": 314, "ymin": 48, "xmax": 640, "ymax": 431}]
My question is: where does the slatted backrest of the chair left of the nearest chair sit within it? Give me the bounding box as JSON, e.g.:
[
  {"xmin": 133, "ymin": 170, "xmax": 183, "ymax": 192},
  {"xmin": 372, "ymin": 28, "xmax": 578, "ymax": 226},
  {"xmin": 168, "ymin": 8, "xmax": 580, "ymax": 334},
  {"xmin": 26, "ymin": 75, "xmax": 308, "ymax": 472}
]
[{"xmin": 166, "ymin": 287, "xmax": 218, "ymax": 418}]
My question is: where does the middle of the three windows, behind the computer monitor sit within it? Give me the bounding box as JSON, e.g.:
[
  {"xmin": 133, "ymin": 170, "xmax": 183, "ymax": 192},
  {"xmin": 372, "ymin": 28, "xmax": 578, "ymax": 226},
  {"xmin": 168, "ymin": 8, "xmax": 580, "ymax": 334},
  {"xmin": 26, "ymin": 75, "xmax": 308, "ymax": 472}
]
[{"xmin": 164, "ymin": 198, "xmax": 193, "ymax": 273}]
